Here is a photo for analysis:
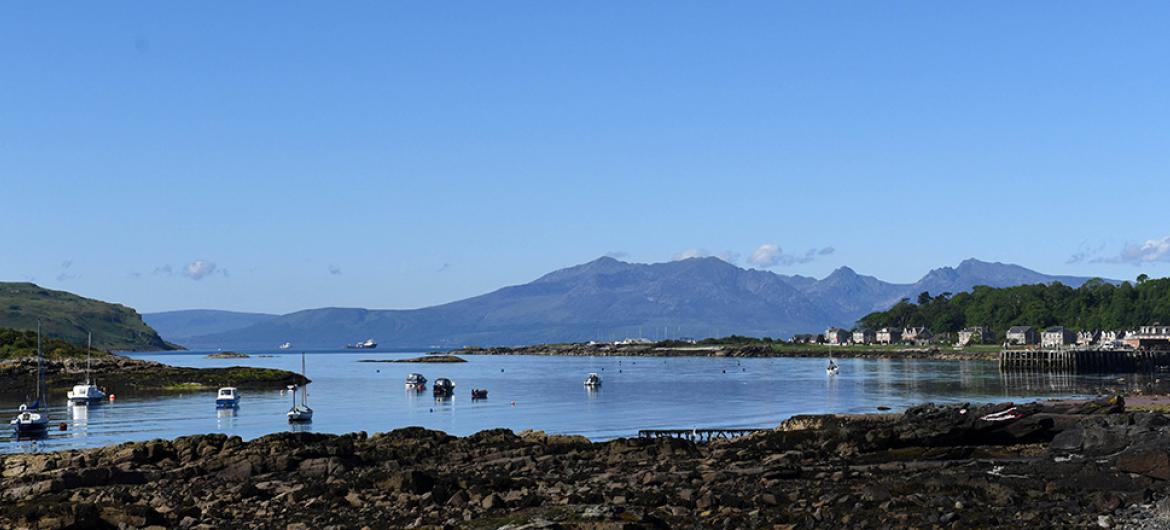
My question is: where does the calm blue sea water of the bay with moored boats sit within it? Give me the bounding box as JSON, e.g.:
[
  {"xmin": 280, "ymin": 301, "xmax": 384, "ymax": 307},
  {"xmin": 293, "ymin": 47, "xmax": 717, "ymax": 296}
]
[{"xmin": 0, "ymin": 351, "xmax": 1143, "ymax": 453}]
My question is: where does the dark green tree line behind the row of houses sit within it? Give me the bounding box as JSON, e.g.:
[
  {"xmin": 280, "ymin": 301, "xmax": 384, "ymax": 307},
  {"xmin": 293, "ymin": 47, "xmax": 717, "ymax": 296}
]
[{"xmin": 858, "ymin": 275, "xmax": 1170, "ymax": 336}]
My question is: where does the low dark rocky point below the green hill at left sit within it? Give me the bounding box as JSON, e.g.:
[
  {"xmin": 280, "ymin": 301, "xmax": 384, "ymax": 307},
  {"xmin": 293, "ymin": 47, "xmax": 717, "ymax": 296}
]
[{"xmin": 0, "ymin": 353, "xmax": 308, "ymax": 394}]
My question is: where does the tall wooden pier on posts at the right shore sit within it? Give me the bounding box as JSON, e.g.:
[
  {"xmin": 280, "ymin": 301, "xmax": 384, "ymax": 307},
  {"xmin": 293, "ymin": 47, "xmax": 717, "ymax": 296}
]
[{"xmin": 999, "ymin": 349, "xmax": 1170, "ymax": 373}]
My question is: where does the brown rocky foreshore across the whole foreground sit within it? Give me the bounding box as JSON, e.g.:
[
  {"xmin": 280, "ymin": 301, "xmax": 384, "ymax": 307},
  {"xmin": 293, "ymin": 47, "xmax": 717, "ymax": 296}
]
[{"xmin": 0, "ymin": 398, "xmax": 1170, "ymax": 530}]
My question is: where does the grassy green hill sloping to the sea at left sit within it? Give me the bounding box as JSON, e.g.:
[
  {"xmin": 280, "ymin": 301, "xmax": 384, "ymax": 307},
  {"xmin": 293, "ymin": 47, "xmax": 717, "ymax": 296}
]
[{"xmin": 0, "ymin": 282, "xmax": 176, "ymax": 351}]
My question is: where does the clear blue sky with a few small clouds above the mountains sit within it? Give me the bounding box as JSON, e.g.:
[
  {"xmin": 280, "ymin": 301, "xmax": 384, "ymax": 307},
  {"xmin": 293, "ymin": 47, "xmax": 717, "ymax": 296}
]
[{"xmin": 0, "ymin": 1, "xmax": 1170, "ymax": 312}]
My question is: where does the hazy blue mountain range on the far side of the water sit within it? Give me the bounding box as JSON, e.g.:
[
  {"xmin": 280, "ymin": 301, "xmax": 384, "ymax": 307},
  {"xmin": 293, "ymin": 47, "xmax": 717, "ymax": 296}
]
[{"xmin": 143, "ymin": 257, "xmax": 1113, "ymax": 349}]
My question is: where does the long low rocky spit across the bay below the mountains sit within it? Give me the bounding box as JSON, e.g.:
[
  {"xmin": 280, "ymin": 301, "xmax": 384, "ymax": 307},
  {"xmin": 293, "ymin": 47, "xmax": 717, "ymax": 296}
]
[{"xmin": 449, "ymin": 344, "xmax": 998, "ymax": 360}]
